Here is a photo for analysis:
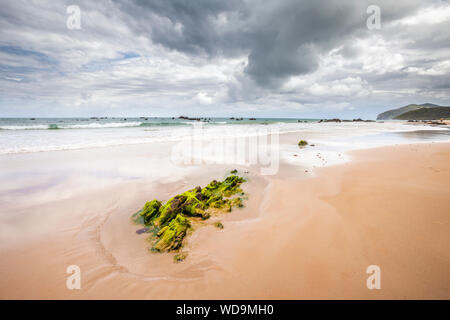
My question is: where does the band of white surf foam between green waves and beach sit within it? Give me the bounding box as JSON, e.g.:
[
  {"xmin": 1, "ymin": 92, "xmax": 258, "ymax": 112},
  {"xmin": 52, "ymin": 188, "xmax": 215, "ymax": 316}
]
[{"xmin": 0, "ymin": 121, "xmax": 448, "ymax": 155}]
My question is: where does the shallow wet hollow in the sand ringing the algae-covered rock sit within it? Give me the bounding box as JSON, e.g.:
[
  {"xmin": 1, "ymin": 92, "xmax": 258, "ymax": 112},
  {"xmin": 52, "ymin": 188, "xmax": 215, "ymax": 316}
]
[{"xmin": 100, "ymin": 170, "xmax": 268, "ymax": 280}]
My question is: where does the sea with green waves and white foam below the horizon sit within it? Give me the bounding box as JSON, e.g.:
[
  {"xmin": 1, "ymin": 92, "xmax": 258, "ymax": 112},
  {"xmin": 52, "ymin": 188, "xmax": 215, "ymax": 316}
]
[{"xmin": 0, "ymin": 117, "xmax": 450, "ymax": 154}]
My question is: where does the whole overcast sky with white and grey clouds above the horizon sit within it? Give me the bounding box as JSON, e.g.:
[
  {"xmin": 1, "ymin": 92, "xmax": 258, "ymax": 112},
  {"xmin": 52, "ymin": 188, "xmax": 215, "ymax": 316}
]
[{"xmin": 0, "ymin": 0, "xmax": 450, "ymax": 118}]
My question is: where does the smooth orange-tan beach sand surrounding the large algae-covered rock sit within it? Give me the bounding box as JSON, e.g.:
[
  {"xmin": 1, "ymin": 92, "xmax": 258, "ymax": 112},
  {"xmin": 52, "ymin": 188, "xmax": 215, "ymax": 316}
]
[{"xmin": 0, "ymin": 143, "xmax": 450, "ymax": 299}]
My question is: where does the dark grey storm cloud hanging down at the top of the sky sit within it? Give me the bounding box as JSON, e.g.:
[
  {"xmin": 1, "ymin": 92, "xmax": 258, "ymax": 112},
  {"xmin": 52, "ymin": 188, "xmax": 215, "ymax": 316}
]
[{"xmin": 120, "ymin": 0, "xmax": 426, "ymax": 87}]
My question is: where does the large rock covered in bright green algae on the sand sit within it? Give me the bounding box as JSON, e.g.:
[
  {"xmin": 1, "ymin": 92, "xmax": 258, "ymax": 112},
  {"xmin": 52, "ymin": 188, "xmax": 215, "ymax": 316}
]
[{"xmin": 132, "ymin": 175, "xmax": 245, "ymax": 252}]
